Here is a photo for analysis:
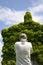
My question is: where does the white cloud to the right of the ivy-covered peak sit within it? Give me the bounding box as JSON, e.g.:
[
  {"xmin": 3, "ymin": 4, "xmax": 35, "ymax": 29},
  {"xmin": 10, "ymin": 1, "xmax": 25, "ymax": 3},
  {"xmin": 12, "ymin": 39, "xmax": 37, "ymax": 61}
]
[{"xmin": 28, "ymin": 4, "xmax": 43, "ymax": 24}]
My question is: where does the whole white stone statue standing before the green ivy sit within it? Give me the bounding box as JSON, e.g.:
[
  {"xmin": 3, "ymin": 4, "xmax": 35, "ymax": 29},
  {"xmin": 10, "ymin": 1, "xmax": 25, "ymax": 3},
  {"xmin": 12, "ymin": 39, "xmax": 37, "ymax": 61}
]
[{"xmin": 14, "ymin": 33, "xmax": 32, "ymax": 65}]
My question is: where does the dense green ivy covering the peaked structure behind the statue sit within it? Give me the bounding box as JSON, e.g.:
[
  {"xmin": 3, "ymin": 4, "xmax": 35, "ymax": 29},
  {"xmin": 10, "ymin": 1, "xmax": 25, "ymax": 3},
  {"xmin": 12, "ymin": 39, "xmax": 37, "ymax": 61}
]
[{"xmin": 2, "ymin": 12, "xmax": 43, "ymax": 65}]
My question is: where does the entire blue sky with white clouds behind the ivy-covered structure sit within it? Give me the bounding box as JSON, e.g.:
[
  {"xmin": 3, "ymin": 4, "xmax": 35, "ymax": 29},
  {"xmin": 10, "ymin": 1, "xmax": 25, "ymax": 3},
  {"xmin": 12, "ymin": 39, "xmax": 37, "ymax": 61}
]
[{"xmin": 0, "ymin": 0, "xmax": 43, "ymax": 65}]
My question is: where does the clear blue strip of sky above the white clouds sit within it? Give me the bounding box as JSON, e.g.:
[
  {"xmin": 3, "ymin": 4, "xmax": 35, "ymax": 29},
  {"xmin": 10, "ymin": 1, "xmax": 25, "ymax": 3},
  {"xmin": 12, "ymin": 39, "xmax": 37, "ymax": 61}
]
[{"xmin": 0, "ymin": 0, "xmax": 40, "ymax": 10}]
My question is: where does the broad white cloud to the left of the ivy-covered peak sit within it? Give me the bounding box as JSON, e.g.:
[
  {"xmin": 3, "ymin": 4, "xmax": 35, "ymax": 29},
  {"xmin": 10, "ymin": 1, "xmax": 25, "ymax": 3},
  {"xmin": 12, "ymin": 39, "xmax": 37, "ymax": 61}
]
[{"xmin": 0, "ymin": 7, "xmax": 25, "ymax": 24}]
